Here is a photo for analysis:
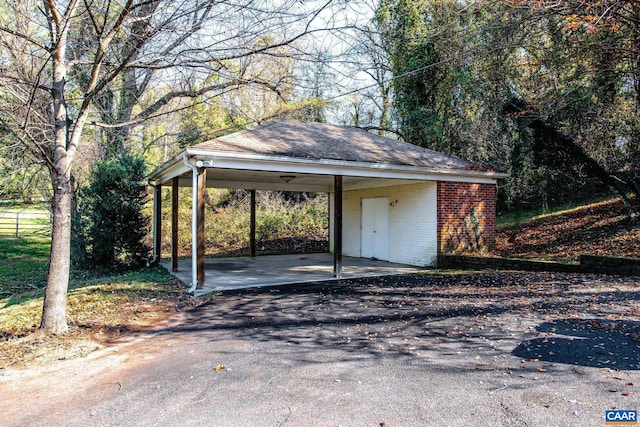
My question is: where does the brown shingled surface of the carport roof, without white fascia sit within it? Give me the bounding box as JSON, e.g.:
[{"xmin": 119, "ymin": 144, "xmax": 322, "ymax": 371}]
[{"xmin": 192, "ymin": 119, "xmax": 490, "ymax": 171}]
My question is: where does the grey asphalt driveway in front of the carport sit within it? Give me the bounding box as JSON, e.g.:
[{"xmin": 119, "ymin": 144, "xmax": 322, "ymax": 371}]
[{"xmin": 0, "ymin": 273, "xmax": 640, "ymax": 426}]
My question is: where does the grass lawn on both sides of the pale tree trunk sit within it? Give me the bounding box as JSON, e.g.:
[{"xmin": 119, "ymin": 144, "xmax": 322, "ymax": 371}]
[{"xmin": 0, "ymin": 237, "xmax": 188, "ymax": 344}]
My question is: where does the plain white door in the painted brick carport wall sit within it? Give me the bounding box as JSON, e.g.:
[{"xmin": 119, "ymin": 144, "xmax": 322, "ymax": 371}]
[{"xmin": 360, "ymin": 197, "xmax": 389, "ymax": 261}]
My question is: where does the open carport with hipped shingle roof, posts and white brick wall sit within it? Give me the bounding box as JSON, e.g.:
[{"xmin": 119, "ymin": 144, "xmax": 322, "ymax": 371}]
[{"xmin": 149, "ymin": 120, "xmax": 504, "ymax": 291}]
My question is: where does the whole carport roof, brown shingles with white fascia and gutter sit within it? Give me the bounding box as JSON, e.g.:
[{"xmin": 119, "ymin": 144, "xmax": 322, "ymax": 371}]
[{"xmin": 149, "ymin": 119, "xmax": 506, "ymax": 185}]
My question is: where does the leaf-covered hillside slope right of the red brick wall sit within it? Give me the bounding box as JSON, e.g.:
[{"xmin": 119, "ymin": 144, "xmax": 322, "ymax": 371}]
[{"xmin": 496, "ymin": 199, "xmax": 640, "ymax": 261}]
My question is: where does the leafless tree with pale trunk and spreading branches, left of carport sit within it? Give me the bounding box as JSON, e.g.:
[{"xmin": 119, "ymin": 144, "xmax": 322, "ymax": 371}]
[{"xmin": 0, "ymin": 0, "xmax": 344, "ymax": 333}]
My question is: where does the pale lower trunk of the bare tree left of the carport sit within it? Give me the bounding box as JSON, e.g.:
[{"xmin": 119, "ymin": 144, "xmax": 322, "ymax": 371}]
[{"xmin": 40, "ymin": 173, "xmax": 72, "ymax": 334}]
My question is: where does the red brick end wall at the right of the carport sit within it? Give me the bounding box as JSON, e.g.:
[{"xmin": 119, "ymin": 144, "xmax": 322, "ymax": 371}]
[{"xmin": 438, "ymin": 181, "xmax": 496, "ymax": 254}]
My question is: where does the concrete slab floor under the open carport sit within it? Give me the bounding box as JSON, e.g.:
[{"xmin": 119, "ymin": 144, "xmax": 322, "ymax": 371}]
[{"xmin": 161, "ymin": 253, "xmax": 424, "ymax": 296}]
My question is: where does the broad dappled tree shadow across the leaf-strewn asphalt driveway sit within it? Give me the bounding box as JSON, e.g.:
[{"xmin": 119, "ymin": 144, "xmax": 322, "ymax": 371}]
[{"xmin": 146, "ymin": 272, "xmax": 640, "ymax": 370}]
